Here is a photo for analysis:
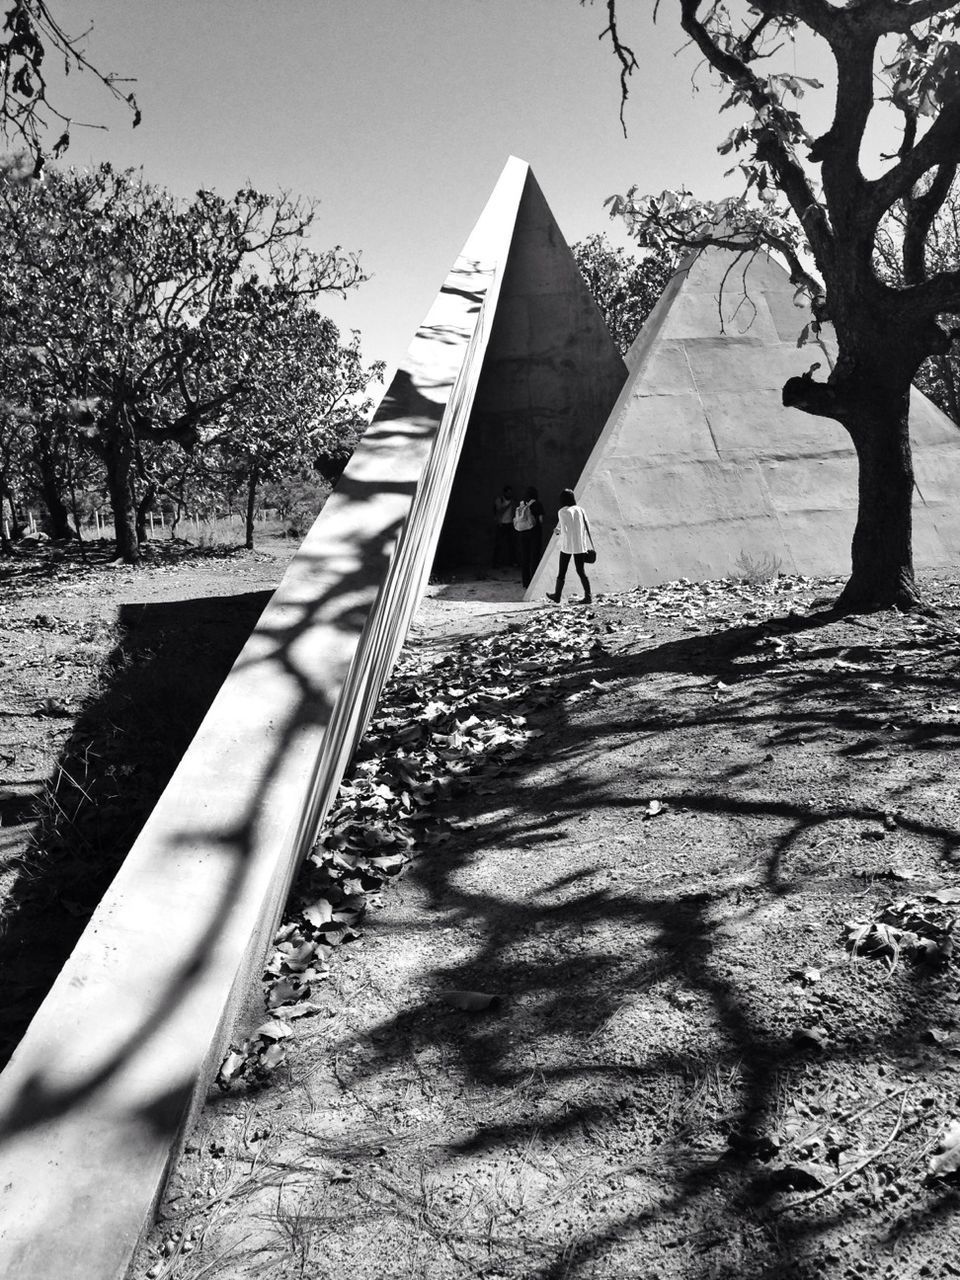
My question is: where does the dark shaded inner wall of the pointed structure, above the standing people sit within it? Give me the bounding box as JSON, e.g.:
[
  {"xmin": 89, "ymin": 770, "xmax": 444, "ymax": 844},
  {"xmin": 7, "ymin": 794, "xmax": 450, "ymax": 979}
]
[{"xmin": 438, "ymin": 173, "xmax": 627, "ymax": 567}]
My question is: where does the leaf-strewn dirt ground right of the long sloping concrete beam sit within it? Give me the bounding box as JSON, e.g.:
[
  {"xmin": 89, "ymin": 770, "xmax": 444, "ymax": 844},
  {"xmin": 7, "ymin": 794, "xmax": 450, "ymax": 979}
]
[{"xmin": 3, "ymin": 547, "xmax": 960, "ymax": 1280}]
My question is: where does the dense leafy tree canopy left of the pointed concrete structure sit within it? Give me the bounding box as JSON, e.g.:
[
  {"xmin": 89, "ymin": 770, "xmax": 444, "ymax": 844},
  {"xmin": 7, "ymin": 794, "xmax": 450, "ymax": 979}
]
[{"xmin": 0, "ymin": 164, "xmax": 376, "ymax": 563}]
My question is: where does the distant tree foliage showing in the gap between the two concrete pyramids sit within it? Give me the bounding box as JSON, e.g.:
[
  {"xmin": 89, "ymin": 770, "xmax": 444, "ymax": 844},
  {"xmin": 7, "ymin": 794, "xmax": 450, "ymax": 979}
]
[{"xmin": 573, "ymin": 234, "xmax": 676, "ymax": 356}]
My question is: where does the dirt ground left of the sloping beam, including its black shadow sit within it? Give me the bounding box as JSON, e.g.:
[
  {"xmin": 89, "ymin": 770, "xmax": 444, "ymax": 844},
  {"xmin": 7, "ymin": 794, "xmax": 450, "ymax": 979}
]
[{"xmin": 0, "ymin": 539, "xmax": 297, "ymax": 1066}]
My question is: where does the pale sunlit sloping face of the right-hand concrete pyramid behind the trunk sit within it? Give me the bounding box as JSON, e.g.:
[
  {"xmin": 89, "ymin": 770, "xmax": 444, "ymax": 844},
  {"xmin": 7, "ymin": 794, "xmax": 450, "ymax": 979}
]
[{"xmin": 529, "ymin": 248, "xmax": 960, "ymax": 599}]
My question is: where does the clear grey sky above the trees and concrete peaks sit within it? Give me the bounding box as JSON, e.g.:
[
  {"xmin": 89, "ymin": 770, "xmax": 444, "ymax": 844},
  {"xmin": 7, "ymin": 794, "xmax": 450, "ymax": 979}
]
[{"xmin": 33, "ymin": 0, "xmax": 839, "ymax": 378}]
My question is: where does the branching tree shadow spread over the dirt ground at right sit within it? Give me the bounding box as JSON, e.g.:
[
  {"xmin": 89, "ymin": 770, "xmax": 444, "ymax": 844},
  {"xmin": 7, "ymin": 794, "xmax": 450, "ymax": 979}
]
[{"xmin": 273, "ymin": 599, "xmax": 960, "ymax": 1280}]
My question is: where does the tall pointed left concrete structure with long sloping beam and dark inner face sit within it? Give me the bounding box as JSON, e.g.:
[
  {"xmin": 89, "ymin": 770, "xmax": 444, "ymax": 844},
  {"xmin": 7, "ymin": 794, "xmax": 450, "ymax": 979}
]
[{"xmin": 0, "ymin": 159, "xmax": 626, "ymax": 1280}]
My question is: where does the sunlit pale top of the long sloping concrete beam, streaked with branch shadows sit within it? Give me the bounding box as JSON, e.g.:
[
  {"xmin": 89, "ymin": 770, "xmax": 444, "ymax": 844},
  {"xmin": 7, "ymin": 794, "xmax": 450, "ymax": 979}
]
[{"xmin": 0, "ymin": 160, "xmax": 527, "ymax": 1280}]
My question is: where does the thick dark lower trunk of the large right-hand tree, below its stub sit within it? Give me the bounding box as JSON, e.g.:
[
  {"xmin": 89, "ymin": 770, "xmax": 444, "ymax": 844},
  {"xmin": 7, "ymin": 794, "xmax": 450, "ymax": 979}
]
[{"xmin": 837, "ymin": 393, "xmax": 919, "ymax": 609}]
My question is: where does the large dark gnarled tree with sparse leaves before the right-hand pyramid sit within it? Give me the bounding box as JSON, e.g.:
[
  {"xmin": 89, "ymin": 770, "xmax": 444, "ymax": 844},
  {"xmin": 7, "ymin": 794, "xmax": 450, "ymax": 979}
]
[{"xmin": 604, "ymin": 0, "xmax": 960, "ymax": 608}]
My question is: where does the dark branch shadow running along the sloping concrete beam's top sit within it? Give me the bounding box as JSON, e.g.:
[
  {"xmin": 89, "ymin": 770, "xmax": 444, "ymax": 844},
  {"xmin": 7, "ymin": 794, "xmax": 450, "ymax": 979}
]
[{"xmin": 0, "ymin": 396, "xmax": 439, "ymax": 1172}]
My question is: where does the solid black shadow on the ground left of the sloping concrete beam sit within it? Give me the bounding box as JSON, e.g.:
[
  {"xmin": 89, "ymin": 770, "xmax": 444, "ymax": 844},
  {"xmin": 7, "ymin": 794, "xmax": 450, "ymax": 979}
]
[{"xmin": 0, "ymin": 591, "xmax": 271, "ymax": 1066}]
